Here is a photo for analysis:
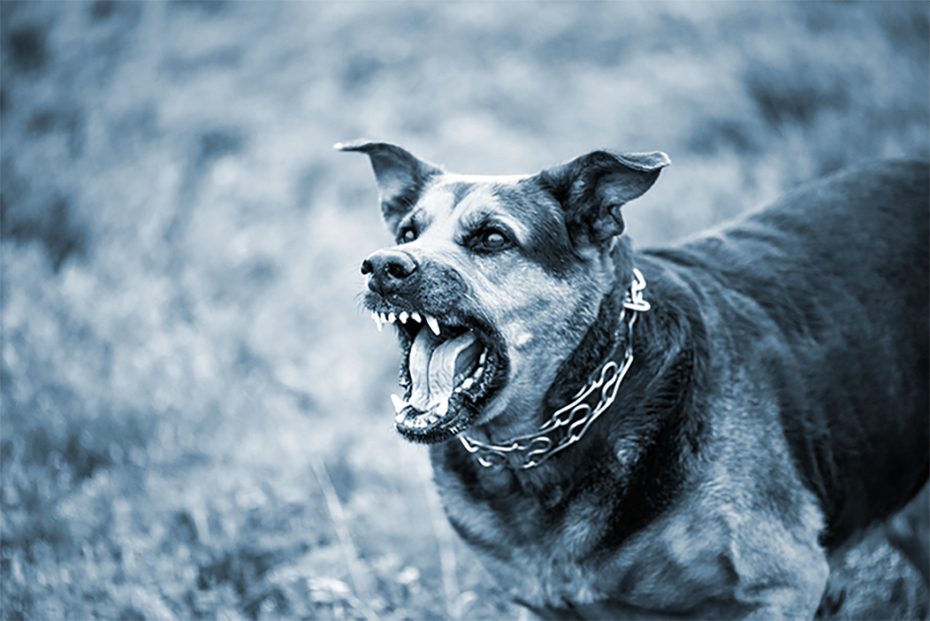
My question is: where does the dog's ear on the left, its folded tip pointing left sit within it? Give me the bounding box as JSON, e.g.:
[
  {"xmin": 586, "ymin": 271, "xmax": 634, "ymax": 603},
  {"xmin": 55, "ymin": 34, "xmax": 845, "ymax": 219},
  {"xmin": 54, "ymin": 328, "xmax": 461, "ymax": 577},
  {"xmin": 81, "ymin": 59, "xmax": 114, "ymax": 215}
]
[{"xmin": 333, "ymin": 140, "xmax": 442, "ymax": 233}]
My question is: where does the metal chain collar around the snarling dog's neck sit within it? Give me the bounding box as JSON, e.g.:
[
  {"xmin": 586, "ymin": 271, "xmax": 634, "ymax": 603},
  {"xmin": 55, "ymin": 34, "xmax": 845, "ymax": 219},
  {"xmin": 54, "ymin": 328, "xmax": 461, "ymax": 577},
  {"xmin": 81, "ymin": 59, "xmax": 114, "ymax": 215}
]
[{"xmin": 459, "ymin": 267, "xmax": 650, "ymax": 470}]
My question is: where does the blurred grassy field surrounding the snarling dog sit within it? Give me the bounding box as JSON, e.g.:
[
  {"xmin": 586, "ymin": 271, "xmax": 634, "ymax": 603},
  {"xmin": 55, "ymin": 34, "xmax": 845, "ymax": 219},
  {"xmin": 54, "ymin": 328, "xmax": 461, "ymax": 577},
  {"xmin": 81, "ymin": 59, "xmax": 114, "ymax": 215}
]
[{"xmin": 0, "ymin": 0, "xmax": 930, "ymax": 619}]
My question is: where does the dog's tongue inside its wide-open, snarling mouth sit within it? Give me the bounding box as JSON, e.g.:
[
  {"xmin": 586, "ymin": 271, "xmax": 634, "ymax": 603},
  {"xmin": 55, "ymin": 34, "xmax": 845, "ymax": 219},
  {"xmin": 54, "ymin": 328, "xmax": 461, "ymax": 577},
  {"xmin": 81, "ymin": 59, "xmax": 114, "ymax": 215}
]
[{"xmin": 408, "ymin": 330, "xmax": 480, "ymax": 416}]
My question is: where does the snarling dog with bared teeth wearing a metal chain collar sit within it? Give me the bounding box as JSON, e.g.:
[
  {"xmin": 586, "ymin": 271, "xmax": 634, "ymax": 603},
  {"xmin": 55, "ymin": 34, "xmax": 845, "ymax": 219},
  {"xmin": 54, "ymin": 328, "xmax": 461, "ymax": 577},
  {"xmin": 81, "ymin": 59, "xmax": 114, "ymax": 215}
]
[{"xmin": 336, "ymin": 141, "xmax": 930, "ymax": 619}]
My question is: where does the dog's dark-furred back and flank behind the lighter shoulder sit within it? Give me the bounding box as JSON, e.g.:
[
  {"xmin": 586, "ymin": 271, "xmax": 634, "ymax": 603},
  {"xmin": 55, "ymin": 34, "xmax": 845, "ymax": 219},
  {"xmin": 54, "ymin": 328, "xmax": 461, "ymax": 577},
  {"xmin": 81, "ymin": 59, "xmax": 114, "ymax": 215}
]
[{"xmin": 654, "ymin": 160, "xmax": 930, "ymax": 547}]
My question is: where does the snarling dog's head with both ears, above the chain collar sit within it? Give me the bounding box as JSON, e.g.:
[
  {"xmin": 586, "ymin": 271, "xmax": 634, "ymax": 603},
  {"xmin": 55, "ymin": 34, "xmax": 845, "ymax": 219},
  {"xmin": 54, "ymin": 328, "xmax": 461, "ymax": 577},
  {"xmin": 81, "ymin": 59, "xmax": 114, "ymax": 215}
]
[{"xmin": 336, "ymin": 142, "xmax": 669, "ymax": 442}]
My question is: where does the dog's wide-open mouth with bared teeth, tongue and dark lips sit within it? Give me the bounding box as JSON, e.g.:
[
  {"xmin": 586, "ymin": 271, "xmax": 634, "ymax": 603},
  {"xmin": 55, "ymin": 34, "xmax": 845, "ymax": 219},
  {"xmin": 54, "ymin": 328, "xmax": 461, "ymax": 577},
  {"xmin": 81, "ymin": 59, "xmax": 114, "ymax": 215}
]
[{"xmin": 371, "ymin": 302, "xmax": 508, "ymax": 443}]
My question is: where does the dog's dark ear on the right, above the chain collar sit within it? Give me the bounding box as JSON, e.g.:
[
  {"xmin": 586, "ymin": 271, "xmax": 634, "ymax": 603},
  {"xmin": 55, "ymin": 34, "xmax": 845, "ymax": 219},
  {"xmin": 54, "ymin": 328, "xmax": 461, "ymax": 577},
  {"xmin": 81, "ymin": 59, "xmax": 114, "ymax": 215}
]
[{"xmin": 537, "ymin": 151, "xmax": 671, "ymax": 244}]
